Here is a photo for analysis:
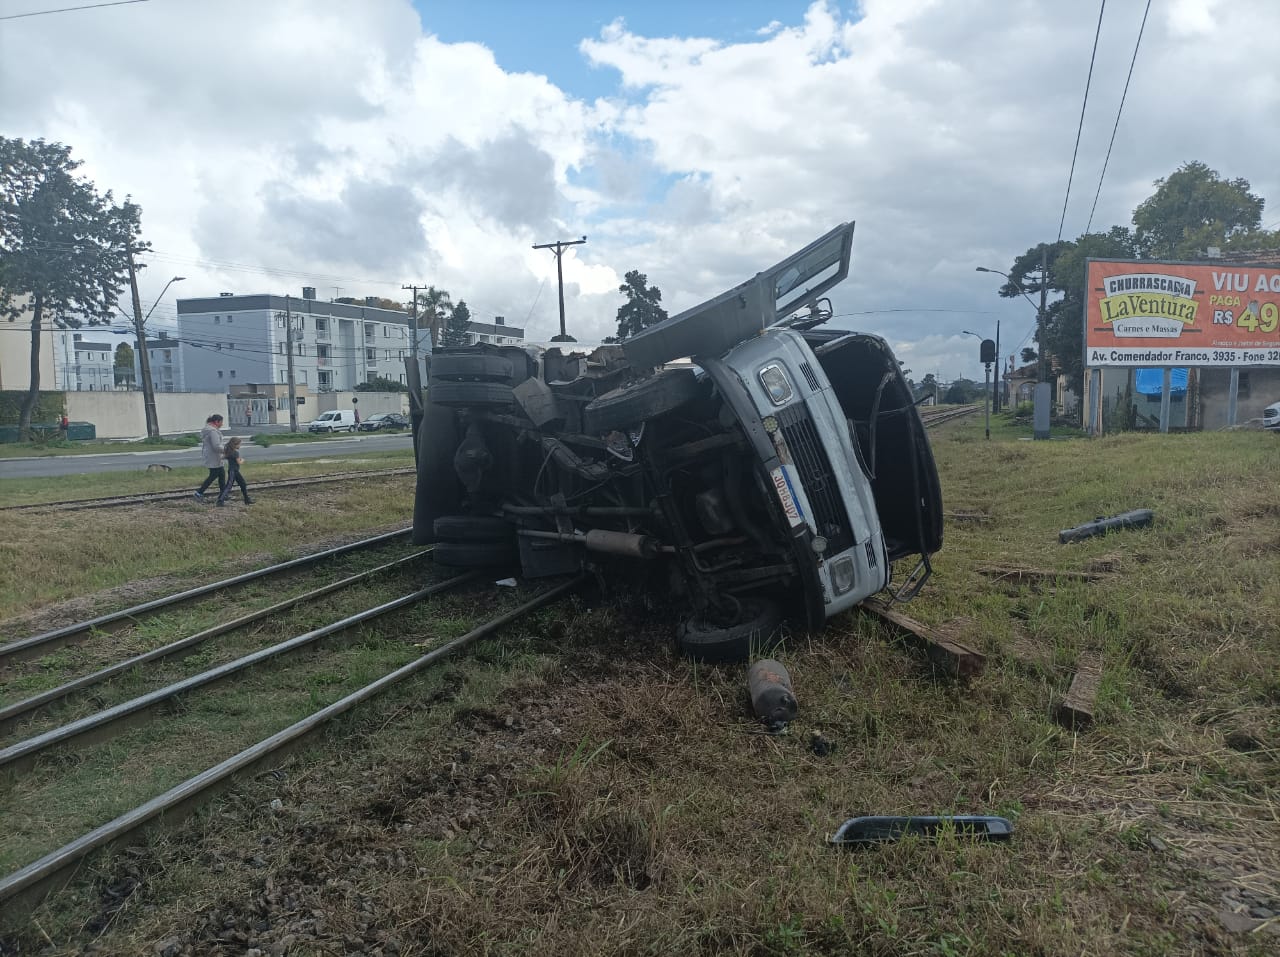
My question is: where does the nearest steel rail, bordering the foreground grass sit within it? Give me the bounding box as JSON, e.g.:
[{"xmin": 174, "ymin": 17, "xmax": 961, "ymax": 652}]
[{"xmin": 0, "ymin": 576, "xmax": 584, "ymax": 903}]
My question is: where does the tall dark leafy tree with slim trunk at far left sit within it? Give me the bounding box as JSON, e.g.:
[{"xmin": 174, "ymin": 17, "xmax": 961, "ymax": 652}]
[{"xmin": 0, "ymin": 137, "xmax": 146, "ymax": 436}]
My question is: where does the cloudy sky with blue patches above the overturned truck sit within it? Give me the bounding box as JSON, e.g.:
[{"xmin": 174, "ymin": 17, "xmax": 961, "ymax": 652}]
[{"xmin": 0, "ymin": 0, "xmax": 1280, "ymax": 379}]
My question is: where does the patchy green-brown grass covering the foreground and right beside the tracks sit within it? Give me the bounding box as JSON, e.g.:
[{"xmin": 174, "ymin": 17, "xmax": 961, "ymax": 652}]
[{"xmin": 0, "ymin": 421, "xmax": 1280, "ymax": 957}]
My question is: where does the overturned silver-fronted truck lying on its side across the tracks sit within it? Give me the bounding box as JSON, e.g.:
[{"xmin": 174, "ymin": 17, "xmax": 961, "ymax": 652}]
[{"xmin": 413, "ymin": 224, "xmax": 942, "ymax": 660}]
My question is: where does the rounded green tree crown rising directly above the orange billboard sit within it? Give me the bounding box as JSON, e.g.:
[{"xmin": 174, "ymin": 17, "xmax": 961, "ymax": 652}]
[{"xmin": 1133, "ymin": 161, "xmax": 1263, "ymax": 260}]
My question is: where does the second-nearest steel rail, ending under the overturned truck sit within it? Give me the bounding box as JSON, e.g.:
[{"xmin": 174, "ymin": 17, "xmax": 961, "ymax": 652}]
[{"xmin": 0, "ymin": 572, "xmax": 479, "ymax": 771}]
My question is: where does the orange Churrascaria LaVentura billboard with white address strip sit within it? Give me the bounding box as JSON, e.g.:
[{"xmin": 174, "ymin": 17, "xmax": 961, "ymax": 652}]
[{"xmin": 1084, "ymin": 260, "xmax": 1280, "ymax": 368}]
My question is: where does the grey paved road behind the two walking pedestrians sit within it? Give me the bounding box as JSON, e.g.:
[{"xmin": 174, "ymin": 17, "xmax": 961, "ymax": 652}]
[{"xmin": 0, "ymin": 432, "xmax": 413, "ymax": 479}]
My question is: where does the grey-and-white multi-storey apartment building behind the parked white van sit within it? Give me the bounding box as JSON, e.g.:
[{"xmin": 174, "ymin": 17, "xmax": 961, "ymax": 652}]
[{"xmin": 178, "ymin": 287, "xmax": 412, "ymax": 393}]
